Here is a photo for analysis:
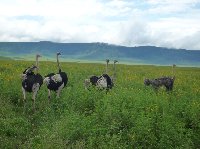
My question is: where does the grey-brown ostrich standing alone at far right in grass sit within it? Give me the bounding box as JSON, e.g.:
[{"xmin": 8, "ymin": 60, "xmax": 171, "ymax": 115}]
[{"xmin": 144, "ymin": 64, "xmax": 176, "ymax": 91}]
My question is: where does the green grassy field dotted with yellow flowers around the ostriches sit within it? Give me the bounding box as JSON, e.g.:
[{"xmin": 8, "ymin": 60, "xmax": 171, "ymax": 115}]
[{"xmin": 0, "ymin": 61, "xmax": 200, "ymax": 149}]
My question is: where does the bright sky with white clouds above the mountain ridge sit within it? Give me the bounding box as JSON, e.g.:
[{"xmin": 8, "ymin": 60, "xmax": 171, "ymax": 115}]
[{"xmin": 0, "ymin": 0, "xmax": 200, "ymax": 50}]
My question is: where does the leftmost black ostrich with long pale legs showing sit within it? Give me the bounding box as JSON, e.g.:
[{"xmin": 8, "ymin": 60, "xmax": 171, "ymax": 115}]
[{"xmin": 22, "ymin": 54, "xmax": 43, "ymax": 111}]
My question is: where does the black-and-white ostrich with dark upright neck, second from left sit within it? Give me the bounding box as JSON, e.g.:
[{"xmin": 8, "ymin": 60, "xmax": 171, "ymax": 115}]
[{"xmin": 44, "ymin": 53, "xmax": 68, "ymax": 100}]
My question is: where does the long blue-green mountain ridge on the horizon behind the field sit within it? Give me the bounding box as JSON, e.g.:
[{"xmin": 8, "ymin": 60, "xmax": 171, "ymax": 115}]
[{"xmin": 0, "ymin": 41, "xmax": 200, "ymax": 66}]
